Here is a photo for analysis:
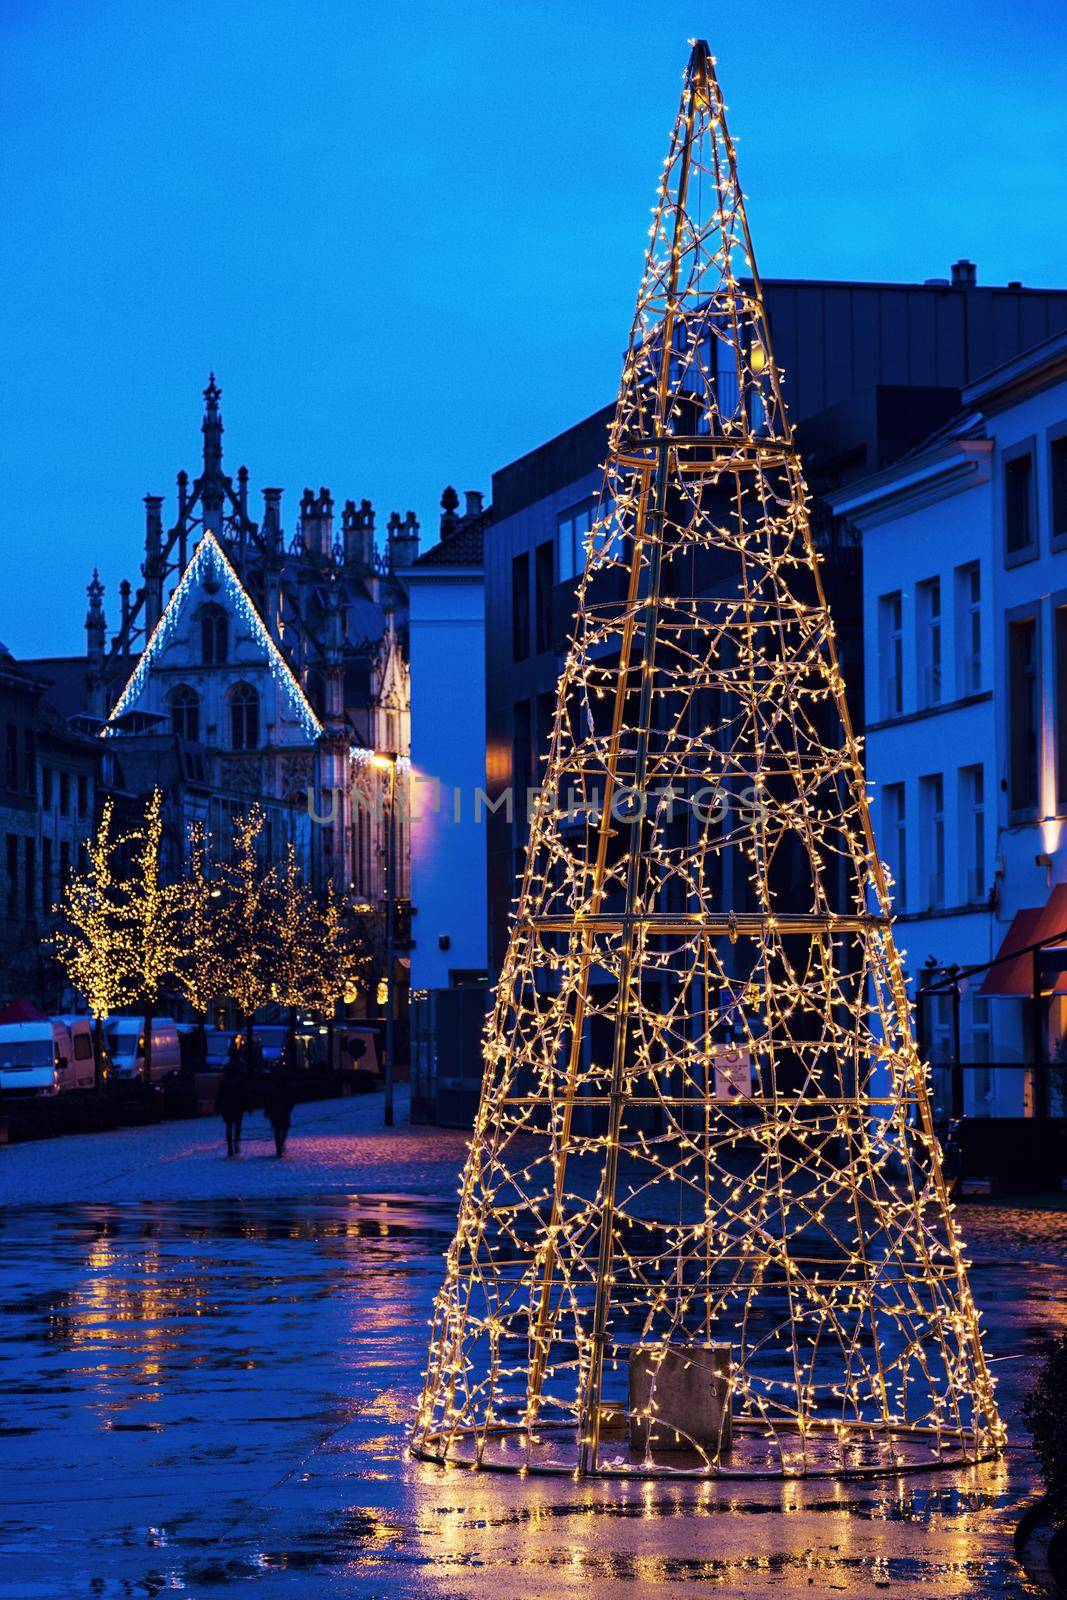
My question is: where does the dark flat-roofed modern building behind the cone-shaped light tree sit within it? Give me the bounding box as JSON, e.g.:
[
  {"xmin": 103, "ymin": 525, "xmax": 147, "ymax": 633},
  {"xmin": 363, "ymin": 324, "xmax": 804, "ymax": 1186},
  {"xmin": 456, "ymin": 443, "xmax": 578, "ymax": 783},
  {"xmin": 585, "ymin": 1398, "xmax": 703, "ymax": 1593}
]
[{"xmin": 485, "ymin": 261, "xmax": 1067, "ymax": 973}]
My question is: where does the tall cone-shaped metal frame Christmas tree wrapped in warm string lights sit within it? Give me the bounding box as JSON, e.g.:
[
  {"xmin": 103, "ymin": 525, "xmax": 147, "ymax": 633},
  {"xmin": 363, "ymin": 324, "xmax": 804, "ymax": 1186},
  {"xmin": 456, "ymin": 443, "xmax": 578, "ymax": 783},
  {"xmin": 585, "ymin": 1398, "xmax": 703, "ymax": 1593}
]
[{"xmin": 414, "ymin": 43, "xmax": 1001, "ymax": 1475}]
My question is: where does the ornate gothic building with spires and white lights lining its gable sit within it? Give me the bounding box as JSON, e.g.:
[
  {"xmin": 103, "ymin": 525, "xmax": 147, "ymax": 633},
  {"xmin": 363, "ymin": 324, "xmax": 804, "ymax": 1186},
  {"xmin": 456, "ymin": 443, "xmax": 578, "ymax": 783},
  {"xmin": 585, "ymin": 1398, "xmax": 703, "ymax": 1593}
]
[{"xmin": 29, "ymin": 374, "xmax": 419, "ymax": 902}]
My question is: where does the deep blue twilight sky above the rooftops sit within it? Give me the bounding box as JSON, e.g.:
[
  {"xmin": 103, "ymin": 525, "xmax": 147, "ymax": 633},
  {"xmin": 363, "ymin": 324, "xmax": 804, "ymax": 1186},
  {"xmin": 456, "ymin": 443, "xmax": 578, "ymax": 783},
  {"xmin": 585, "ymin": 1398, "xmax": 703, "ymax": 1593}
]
[{"xmin": 0, "ymin": 0, "xmax": 1067, "ymax": 654}]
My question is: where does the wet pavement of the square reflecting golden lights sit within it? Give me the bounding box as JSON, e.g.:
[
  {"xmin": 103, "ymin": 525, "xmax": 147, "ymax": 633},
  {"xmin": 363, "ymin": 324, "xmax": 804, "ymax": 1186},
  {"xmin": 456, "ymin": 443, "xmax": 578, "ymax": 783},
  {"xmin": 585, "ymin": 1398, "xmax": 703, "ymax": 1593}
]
[{"xmin": 0, "ymin": 1098, "xmax": 1067, "ymax": 1600}]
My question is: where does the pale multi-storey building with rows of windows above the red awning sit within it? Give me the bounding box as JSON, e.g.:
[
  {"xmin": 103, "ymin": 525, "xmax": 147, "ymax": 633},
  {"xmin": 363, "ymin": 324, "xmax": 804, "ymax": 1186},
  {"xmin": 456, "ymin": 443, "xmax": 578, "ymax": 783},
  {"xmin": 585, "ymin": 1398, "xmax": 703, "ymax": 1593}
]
[{"xmin": 833, "ymin": 334, "xmax": 1067, "ymax": 1117}]
